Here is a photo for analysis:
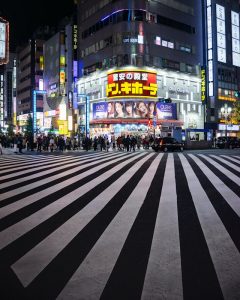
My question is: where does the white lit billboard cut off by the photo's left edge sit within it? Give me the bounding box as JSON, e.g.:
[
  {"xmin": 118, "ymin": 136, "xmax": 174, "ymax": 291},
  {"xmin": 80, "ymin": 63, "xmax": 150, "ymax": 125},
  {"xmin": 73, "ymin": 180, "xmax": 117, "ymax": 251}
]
[{"xmin": 0, "ymin": 18, "xmax": 9, "ymax": 65}]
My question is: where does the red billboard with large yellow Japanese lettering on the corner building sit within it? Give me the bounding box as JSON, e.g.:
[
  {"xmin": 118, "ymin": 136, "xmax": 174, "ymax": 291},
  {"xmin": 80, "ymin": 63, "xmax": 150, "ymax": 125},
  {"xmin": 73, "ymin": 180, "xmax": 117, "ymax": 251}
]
[{"xmin": 106, "ymin": 70, "xmax": 157, "ymax": 99}]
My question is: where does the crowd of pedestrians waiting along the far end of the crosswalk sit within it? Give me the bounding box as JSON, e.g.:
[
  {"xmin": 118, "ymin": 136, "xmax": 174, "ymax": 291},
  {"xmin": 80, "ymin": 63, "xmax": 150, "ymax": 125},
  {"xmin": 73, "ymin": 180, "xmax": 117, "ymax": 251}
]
[{"xmin": 0, "ymin": 134, "xmax": 154, "ymax": 154}]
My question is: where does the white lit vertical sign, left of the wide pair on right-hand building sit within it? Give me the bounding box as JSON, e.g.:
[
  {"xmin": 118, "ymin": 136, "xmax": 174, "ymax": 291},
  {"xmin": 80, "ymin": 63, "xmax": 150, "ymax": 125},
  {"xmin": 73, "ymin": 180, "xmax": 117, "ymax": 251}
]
[{"xmin": 216, "ymin": 4, "xmax": 227, "ymax": 63}]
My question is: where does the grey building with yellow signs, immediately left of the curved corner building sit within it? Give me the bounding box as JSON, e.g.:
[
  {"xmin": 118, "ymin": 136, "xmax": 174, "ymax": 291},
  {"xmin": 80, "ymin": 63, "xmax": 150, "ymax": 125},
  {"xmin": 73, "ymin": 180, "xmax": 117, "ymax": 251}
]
[{"xmin": 43, "ymin": 17, "xmax": 77, "ymax": 135}]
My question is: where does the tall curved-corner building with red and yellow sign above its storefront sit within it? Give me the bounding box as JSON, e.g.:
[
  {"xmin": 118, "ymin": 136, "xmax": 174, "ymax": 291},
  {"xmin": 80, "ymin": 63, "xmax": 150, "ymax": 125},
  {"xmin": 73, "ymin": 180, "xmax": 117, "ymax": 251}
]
[{"xmin": 77, "ymin": 0, "xmax": 204, "ymax": 135}]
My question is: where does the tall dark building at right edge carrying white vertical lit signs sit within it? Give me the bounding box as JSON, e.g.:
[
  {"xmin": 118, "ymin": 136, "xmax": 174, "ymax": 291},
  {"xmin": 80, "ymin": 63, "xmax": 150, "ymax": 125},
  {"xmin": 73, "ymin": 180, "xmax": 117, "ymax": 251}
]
[{"xmin": 203, "ymin": 0, "xmax": 240, "ymax": 135}]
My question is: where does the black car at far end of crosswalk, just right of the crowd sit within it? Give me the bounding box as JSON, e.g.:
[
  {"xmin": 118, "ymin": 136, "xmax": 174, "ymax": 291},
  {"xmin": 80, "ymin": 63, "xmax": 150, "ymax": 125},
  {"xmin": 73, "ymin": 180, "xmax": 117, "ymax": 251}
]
[{"xmin": 152, "ymin": 137, "xmax": 184, "ymax": 152}]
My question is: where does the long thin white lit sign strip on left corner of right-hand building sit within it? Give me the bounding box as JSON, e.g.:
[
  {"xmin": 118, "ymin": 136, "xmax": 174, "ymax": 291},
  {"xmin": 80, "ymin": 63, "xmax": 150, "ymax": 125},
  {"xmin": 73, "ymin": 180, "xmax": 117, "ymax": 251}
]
[{"xmin": 207, "ymin": 0, "xmax": 213, "ymax": 96}]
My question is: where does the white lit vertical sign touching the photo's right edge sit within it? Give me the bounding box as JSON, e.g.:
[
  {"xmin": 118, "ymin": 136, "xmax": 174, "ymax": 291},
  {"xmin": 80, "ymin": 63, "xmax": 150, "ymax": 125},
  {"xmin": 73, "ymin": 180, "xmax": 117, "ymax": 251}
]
[{"xmin": 231, "ymin": 11, "xmax": 240, "ymax": 67}]
